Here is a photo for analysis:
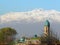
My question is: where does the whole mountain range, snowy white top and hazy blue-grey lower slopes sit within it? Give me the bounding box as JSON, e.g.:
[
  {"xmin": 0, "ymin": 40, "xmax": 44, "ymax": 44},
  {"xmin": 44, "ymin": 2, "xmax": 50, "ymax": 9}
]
[{"xmin": 0, "ymin": 9, "xmax": 60, "ymax": 36}]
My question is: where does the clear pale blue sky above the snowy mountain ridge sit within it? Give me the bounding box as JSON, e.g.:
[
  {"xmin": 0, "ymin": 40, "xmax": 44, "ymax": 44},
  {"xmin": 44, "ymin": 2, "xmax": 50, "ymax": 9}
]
[{"xmin": 0, "ymin": 0, "xmax": 60, "ymax": 15}]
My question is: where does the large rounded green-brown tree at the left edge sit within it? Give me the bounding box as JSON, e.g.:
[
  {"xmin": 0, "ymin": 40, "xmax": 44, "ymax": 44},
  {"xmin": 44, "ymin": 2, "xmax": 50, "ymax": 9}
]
[{"xmin": 0, "ymin": 27, "xmax": 17, "ymax": 45}]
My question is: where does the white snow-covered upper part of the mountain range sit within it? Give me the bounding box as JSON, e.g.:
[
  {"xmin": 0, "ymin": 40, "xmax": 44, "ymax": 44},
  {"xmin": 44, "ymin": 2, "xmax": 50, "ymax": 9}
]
[{"xmin": 0, "ymin": 9, "xmax": 60, "ymax": 23}]
